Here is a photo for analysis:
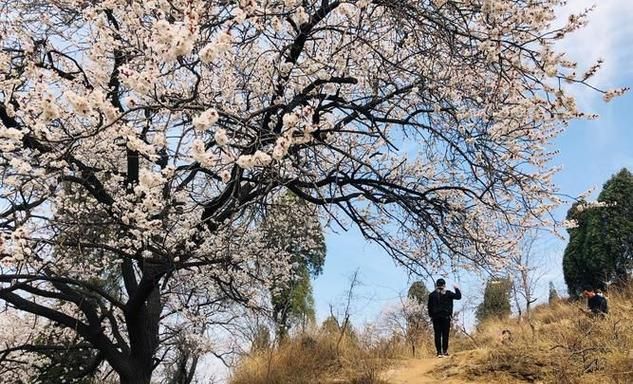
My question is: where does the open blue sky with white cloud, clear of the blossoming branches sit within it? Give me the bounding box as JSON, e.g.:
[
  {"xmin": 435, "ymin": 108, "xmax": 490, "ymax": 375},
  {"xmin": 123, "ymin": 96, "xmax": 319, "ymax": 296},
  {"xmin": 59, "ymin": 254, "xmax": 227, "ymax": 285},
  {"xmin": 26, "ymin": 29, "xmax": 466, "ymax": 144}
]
[{"xmin": 314, "ymin": 0, "xmax": 633, "ymax": 325}]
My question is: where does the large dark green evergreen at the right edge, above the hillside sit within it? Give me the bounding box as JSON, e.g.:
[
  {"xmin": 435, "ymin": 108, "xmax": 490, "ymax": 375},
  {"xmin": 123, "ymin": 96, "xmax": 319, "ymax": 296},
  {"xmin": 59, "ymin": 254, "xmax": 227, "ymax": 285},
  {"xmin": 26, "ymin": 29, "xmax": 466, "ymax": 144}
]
[{"xmin": 563, "ymin": 169, "xmax": 633, "ymax": 297}]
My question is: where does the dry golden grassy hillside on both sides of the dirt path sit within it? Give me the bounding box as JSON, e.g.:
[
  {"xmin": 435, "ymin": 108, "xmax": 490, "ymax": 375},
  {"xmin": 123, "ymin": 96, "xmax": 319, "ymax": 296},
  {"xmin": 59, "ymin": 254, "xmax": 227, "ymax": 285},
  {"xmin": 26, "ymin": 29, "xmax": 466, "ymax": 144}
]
[{"xmin": 231, "ymin": 289, "xmax": 633, "ymax": 384}]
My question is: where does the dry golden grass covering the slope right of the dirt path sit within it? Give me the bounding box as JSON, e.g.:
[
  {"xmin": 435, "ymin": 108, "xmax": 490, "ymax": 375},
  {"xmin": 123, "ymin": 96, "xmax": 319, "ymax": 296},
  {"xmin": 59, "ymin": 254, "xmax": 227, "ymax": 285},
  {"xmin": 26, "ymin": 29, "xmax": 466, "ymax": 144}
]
[{"xmin": 442, "ymin": 288, "xmax": 633, "ymax": 384}]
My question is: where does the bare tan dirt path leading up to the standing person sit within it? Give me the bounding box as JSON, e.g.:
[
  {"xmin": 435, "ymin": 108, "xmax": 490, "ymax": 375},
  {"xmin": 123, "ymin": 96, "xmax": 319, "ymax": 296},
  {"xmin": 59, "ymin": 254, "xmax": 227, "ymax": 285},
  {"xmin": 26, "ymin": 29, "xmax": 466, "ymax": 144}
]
[{"xmin": 383, "ymin": 358, "xmax": 472, "ymax": 384}]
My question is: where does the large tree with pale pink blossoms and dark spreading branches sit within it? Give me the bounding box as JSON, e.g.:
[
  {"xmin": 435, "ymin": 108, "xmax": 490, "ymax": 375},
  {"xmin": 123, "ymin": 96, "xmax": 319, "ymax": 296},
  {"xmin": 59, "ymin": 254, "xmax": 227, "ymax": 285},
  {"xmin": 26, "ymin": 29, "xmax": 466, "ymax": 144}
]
[{"xmin": 0, "ymin": 0, "xmax": 621, "ymax": 383}]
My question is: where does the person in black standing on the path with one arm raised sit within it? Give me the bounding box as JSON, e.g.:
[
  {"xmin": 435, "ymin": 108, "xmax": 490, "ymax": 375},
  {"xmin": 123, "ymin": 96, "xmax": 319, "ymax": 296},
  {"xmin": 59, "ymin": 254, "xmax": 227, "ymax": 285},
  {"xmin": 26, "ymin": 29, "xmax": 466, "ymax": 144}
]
[{"xmin": 428, "ymin": 279, "xmax": 462, "ymax": 357}]
